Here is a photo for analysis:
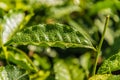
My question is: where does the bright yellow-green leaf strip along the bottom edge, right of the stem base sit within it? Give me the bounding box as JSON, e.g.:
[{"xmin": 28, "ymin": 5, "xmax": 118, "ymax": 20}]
[{"xmin": 89, "ymin": 74, "xmax": 120, "ymax": 80}]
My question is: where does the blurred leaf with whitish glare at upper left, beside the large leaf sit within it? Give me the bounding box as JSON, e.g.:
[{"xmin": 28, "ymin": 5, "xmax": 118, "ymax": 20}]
[{"xmin": 1, "ymin": 10, "xmax": 25, "ymax": 44}]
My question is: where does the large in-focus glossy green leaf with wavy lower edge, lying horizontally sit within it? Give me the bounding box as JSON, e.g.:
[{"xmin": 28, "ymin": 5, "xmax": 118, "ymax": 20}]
[{"xmin": 6, "ymin": 23, "xmax": 94, "ymax": 49}]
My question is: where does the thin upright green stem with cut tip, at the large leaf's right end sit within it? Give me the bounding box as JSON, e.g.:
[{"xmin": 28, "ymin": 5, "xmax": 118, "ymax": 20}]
[{"xmin": 93, "ymin": 15, "xmax": 110, "ymax": 75}]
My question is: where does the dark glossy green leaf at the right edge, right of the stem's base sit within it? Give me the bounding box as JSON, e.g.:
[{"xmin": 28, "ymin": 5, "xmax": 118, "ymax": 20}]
[{"xmin": 97, "ymin": 52, "xmax": 120, "ymax": 74}]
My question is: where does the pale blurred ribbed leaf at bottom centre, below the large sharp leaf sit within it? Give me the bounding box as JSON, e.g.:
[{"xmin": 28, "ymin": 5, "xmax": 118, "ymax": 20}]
[{"xmin": 54, "ymin": 60, "xmax": 72, "ymax": 80}]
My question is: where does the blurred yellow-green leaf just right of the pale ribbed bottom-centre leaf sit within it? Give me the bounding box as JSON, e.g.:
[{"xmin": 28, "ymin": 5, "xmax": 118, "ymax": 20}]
[{"xmin": 65, "ymin": 57, "xmax": 86, "ymax": 80}]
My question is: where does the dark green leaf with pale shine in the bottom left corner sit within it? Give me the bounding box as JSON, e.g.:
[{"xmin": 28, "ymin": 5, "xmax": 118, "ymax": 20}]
[{"xmin": 0, "ymin": 65, "xmax": 29, "ymax": 80}]
